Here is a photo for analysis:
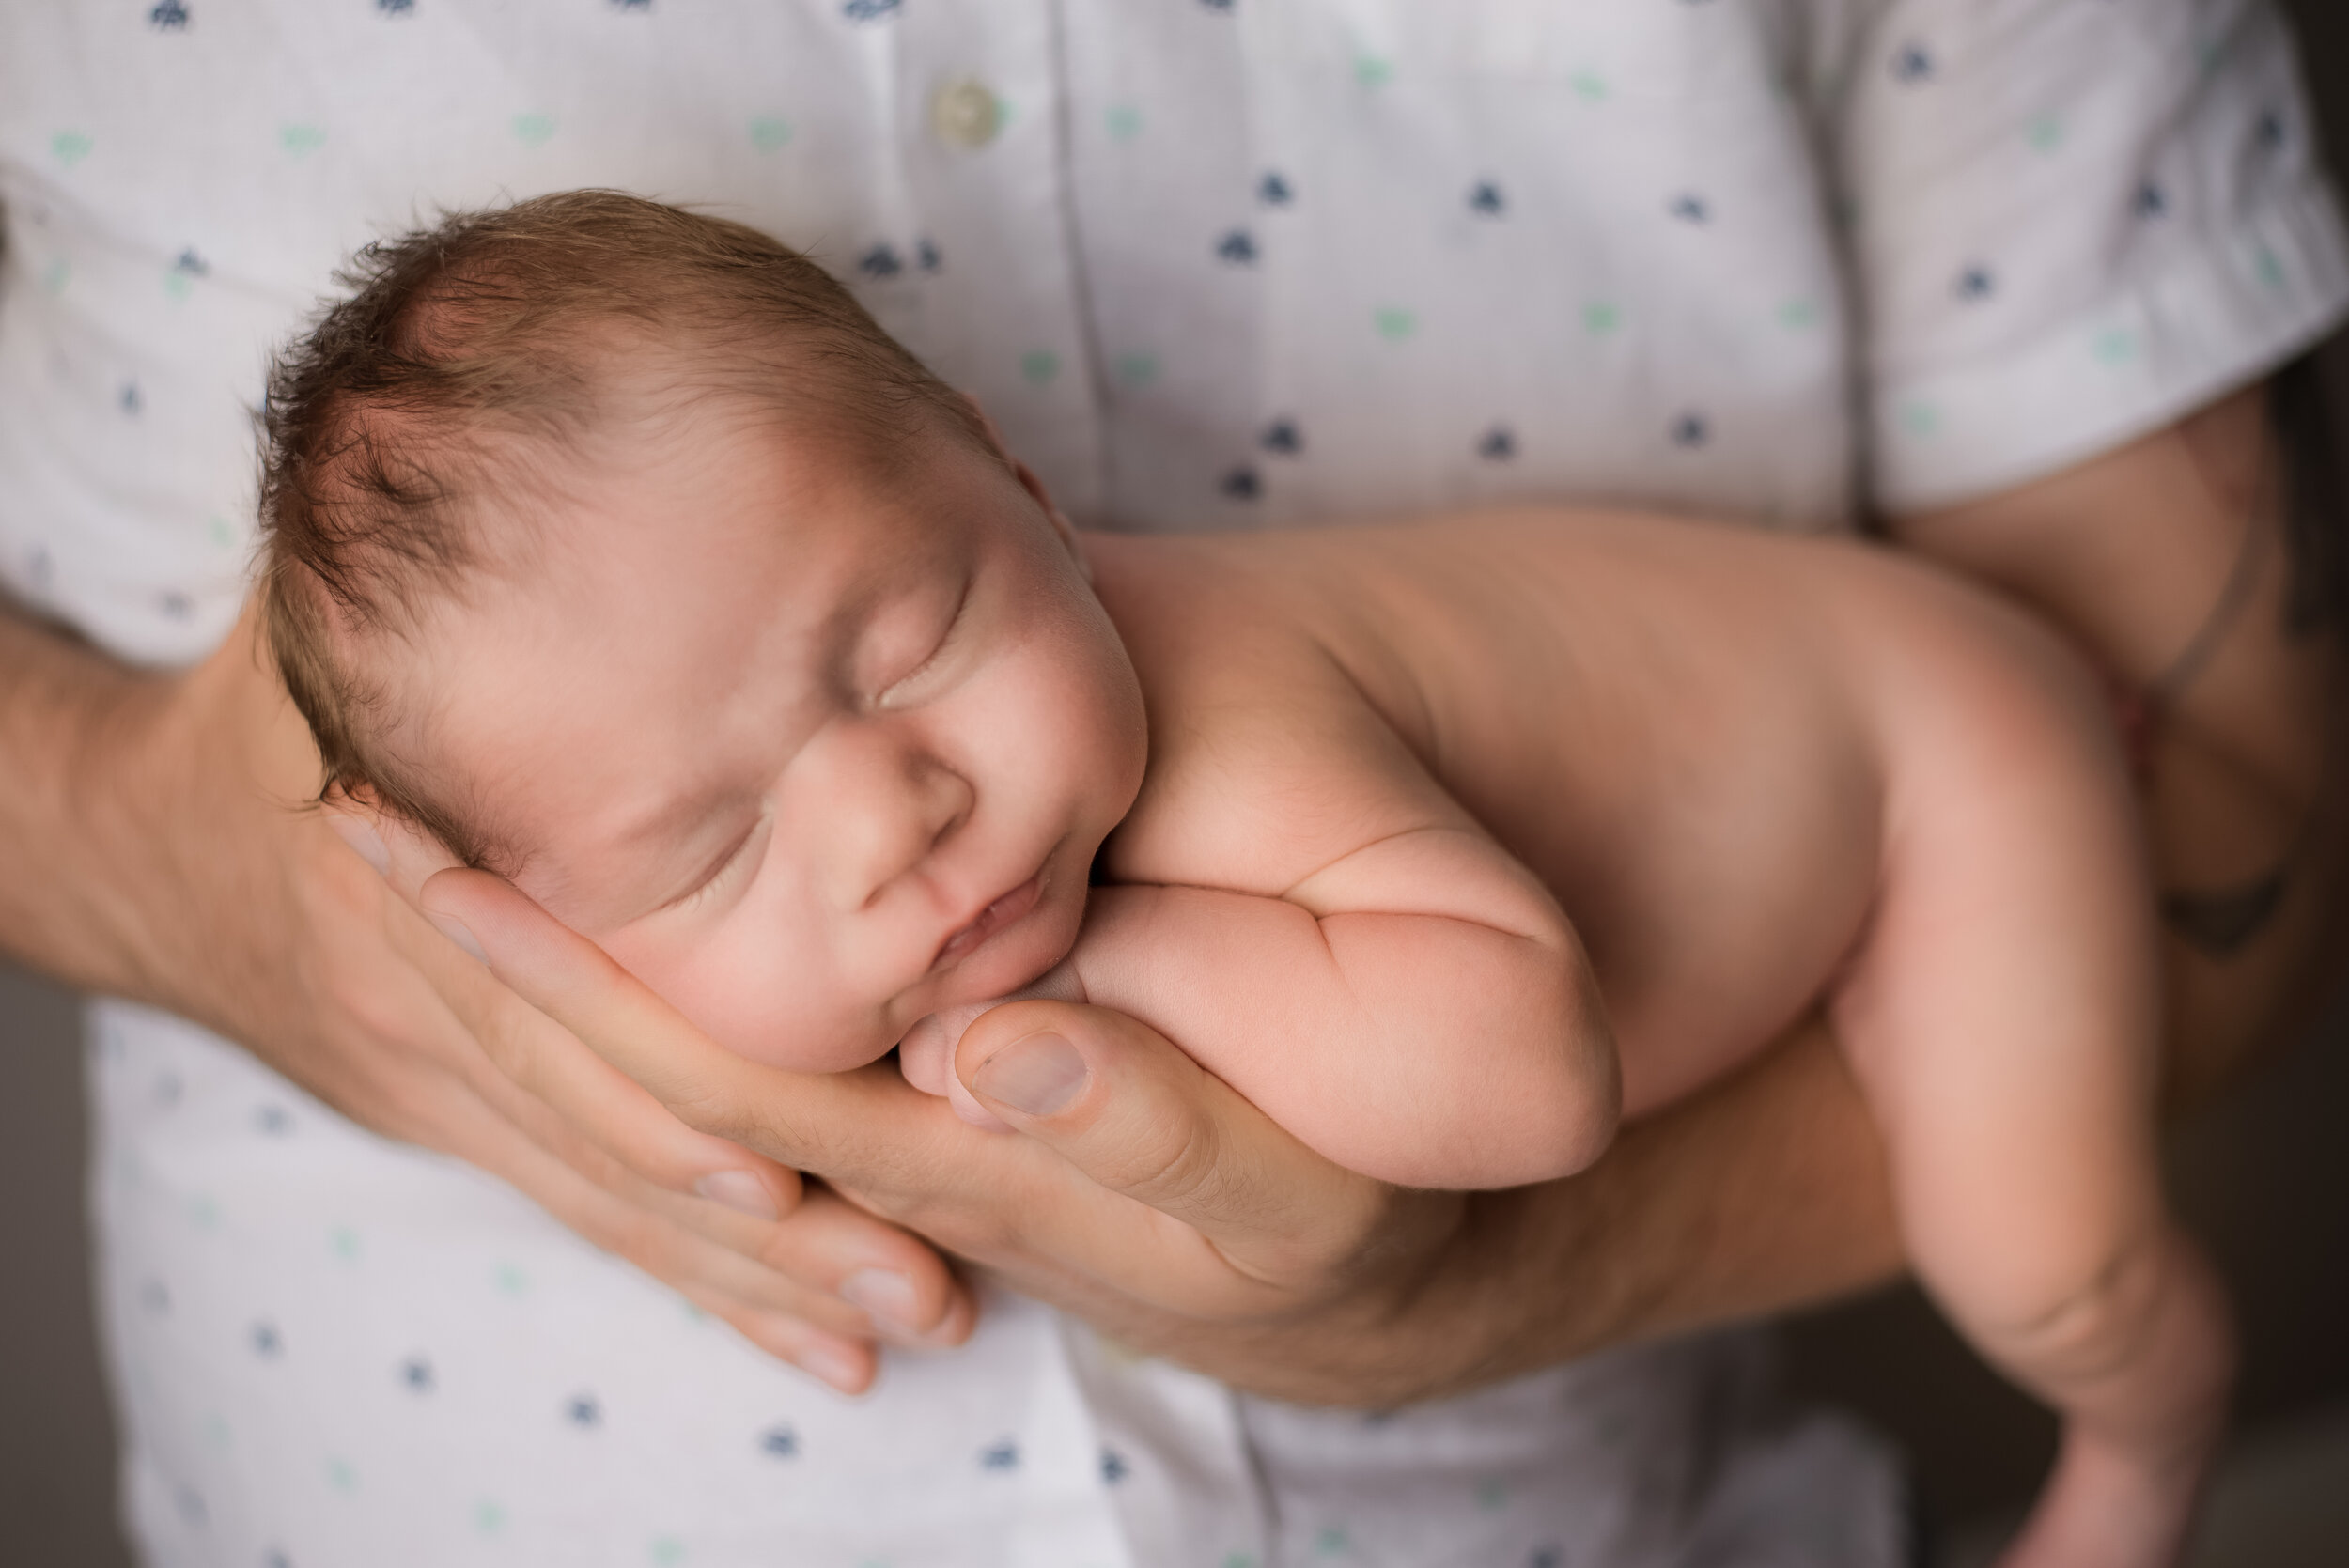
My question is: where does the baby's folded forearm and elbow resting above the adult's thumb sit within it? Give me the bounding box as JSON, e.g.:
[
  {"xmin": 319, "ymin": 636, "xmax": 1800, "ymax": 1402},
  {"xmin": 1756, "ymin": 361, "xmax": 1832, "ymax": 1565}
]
[{"xmin": 1074, "ymin": 826, "xmax": 1619, "ymax": 1188}]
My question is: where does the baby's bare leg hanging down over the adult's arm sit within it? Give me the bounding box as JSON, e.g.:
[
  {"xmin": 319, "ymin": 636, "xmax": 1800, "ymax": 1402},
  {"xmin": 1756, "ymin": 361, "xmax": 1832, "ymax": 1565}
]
[{"xmin": 1835, "ymin": 624, "xmax": 2232, "ymax": 1568}]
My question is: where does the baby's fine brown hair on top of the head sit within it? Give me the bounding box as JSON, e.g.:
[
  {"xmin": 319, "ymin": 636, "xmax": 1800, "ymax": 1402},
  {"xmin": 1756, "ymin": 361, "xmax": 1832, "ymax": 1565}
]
[{"xmin": 258, "ymin": 190, "xmax": 994, "ymax": 863}]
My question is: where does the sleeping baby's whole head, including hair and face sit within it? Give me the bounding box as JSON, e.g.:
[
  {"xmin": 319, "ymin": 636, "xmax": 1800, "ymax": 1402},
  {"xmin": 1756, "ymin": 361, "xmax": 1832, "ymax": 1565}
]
[{"xmin": 261, "ymin": 193, "xmax": 1144, "ymax": 1070}]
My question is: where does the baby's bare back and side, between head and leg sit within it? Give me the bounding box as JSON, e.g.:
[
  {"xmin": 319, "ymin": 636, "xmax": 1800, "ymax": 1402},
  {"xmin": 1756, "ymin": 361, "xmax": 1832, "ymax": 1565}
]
[{"xmin": 1093, "ymin": 512, "xmax": 2058, "ymax": 1115}]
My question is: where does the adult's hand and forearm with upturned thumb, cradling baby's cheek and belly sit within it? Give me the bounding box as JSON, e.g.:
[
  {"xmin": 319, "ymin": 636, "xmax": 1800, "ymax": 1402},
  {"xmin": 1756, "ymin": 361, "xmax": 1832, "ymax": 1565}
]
[{"xmin": 423, "ymin": 871, "xmax": 1896, "ymax": 1406}]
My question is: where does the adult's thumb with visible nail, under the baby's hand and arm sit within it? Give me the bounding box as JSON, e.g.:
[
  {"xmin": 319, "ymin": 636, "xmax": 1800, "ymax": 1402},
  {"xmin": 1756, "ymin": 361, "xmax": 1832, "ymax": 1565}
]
[{"xmin": 957, "ymin": 1000, "xmax": 1395, "ymax": 1305}]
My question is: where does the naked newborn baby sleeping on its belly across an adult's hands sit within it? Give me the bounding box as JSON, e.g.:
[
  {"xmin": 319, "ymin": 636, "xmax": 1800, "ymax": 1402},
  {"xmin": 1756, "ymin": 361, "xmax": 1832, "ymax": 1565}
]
[{"xmin": 263, "ymin": 193, "xmax": 2230, "ymax": 1568}]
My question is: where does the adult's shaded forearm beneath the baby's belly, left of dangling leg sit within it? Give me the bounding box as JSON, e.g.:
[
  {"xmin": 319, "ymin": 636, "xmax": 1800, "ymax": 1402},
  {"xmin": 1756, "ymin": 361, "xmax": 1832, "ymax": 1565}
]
[{"xmin": 1118, "ymin": 1021, "xmax": 1901, "ymax": 1408}]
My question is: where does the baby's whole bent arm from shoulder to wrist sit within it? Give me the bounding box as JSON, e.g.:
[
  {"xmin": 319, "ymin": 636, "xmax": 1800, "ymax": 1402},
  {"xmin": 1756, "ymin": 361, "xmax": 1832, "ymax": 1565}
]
[{"xmin": 1048, "ymin": 647, "xmax": 1619, "ymax": 1188}]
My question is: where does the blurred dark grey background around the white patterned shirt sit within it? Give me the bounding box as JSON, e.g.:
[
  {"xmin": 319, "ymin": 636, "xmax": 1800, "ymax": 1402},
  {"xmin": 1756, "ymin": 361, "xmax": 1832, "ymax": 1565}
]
[{"xmin": 0, "ymin": 0, "xmax": 2349, "ymax": 1568}]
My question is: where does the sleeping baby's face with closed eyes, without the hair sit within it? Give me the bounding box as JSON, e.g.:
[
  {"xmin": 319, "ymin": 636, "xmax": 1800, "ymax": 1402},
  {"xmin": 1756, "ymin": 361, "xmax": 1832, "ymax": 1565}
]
[{"xmin": 393, "ymin": 411, "xmax": 1144, "ymax": 1070}]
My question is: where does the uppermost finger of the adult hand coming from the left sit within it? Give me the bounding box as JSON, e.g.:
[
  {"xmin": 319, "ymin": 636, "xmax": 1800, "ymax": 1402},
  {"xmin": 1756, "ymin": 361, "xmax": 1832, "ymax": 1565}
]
[{"xmin": 395, "ymin": 873, "xmax": 799, "ymax": 1220}]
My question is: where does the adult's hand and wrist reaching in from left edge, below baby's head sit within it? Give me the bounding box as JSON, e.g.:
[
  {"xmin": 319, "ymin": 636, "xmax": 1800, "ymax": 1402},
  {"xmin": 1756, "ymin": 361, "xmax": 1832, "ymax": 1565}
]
[{"xmin": 0, "ymin": 620, "xmax": 971, "ymax": 1389}]
